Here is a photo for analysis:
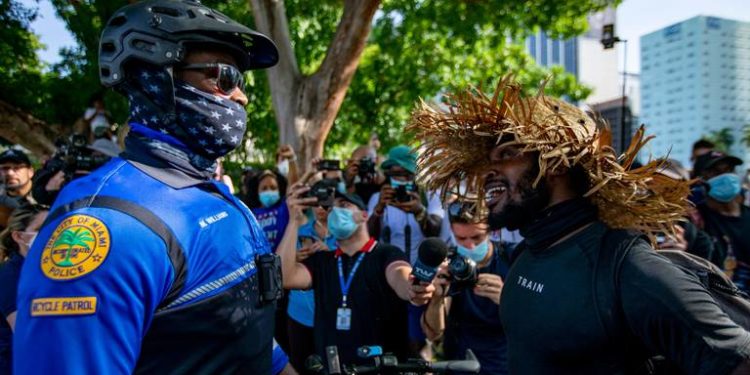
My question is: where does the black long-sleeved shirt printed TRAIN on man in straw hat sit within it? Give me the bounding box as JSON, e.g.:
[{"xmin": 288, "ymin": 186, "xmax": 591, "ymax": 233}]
[{"xmin": 500, "ymin": 223, "xmax": 750, "ymax": 375}]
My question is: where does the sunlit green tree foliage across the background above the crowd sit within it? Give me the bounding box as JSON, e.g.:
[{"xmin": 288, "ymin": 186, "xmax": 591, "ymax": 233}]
[{"xmin": 0, "ymin": 0, "xmax": 617, "ymax": 164}]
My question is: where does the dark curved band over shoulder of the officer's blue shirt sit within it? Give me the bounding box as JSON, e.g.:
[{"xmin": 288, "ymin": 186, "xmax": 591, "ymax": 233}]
[{"xmin": 44, "ymin": 196, "xmax": 187, "ymax": 310}]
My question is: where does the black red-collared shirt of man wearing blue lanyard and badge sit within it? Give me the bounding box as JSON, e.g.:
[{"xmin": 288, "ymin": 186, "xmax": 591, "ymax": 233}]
[{"xmin": 304, "ymin": 243, "xmax": 408, "ymax": 364}]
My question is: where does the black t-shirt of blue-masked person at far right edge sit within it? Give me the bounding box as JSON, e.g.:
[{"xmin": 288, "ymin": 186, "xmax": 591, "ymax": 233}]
[{"xmin": 698, "ymin": 206, "xmax": 750, "ymax": 268}]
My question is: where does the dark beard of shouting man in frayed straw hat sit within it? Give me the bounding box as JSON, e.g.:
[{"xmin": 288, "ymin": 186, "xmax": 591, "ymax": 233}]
[{"xmin": 488, "ymin": 168, "xmax": 550, "ymax": 230}]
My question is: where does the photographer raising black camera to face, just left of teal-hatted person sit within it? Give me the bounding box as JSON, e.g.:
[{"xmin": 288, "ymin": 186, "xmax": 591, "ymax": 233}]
[{"xmin": 344, "ymin": 146, "xmax": 385, "ymax": 206}]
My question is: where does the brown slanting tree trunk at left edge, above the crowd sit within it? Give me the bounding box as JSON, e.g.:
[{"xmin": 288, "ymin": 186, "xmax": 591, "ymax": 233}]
[{"xmin": 0, "ymin": 100, "xmax": 60, "ymax": 159}]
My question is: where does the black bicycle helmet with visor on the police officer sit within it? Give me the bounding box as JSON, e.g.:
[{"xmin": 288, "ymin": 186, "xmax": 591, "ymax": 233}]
[{"xmin": 99, "ymin": 0, "xmax": 279, "ymax": 87}]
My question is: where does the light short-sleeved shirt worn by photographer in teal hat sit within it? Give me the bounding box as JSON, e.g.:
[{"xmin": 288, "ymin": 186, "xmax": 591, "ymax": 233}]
[{"xmin": 367, "ymin": 193, "xmax": 445, "ymax": 263}]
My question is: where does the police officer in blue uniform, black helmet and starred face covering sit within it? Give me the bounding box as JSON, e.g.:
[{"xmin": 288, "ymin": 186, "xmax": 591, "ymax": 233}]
[{"xmin": 14, "ymin": 0, "xmax": 278, "ymax": 374}]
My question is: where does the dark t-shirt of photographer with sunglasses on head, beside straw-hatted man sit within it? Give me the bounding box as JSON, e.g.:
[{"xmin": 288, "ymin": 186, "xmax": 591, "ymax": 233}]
[{"xmin": 443, "ymin": 242, "xmax": 510, "ymax": 375}]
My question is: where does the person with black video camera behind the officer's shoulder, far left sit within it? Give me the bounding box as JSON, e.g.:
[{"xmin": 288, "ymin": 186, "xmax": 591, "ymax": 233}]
[{"xmin": 31, "ymin": 135, "xmax": 121, "ymax": 205}]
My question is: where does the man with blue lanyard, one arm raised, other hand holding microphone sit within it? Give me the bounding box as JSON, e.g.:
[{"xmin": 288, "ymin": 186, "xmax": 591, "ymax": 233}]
[{"xmin": 278, "ymin": 178, "xmax": 434, "ymax": 364}]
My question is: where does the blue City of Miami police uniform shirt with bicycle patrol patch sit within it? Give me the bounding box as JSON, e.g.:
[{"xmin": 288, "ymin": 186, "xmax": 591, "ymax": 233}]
[{"xmin": 13, "ymin": 158, "xmax": 273, "ymax": 374}]
